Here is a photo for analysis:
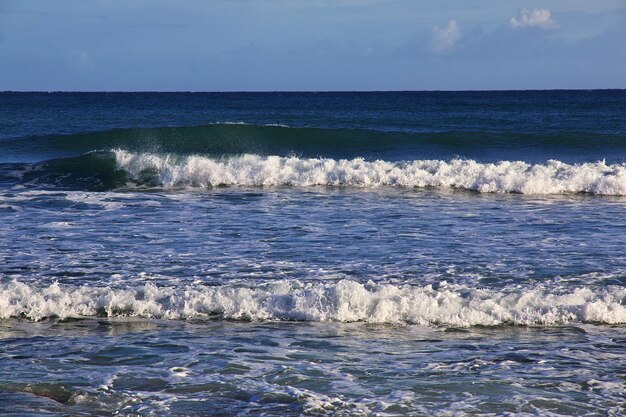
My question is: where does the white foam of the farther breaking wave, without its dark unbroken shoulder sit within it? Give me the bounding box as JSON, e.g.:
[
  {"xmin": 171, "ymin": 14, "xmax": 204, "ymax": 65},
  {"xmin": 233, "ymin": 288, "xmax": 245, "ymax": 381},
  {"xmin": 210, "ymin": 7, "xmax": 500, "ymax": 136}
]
[{"xmin": 115, "ymin": 150, "xmax": 626, "ymax": 195}]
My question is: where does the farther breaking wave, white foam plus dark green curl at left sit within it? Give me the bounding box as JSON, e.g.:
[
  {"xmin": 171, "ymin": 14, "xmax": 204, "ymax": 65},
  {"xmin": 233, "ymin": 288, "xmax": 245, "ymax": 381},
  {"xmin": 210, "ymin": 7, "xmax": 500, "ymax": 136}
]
[{"xmin": 0, "ymin": 149, "xmax": 626, "ymax": 196}]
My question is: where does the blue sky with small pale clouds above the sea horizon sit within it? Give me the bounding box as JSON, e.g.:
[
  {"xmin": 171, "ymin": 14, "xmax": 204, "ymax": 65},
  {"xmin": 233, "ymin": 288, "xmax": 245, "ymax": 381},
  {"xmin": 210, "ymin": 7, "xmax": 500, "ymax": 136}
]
[{"xmin": 0, "ymin": 0, "xmax": 626, "ymax": 91}]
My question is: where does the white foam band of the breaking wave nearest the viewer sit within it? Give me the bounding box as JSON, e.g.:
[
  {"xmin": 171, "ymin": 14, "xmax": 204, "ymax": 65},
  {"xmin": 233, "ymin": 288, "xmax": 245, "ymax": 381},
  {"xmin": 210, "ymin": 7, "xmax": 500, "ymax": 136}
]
[{"xmin": 0, "ymin": 280, "xmax": 626, "ymax": 326}]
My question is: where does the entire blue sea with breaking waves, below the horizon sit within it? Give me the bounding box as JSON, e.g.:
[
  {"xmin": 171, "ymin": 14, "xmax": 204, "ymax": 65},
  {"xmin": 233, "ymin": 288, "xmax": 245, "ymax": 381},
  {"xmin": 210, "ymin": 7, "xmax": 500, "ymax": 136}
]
[{"xmin": 0, "ymin": 90, "xmax": 626, "ymax": 416}]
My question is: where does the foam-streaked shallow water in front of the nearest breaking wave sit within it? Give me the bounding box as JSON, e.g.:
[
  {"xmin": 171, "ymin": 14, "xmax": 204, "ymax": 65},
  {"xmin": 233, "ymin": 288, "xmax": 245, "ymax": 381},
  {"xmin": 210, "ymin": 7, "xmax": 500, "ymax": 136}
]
[{"xmin": 0, "ymin": 319, "xmax": 626, "ymax": 416}]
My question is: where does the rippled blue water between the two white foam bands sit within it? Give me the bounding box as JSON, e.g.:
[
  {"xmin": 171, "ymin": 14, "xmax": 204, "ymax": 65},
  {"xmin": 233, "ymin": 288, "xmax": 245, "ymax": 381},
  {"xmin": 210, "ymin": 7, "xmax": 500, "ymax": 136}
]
[{"xmin": 0, "ymin": 187, "xmax": 626, "ymax": 288}]
